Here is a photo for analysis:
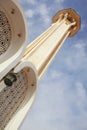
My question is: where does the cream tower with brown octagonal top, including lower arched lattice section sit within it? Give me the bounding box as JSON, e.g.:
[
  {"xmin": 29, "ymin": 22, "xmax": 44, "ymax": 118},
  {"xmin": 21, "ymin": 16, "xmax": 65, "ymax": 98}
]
[{"xmin": 0, "ymin": 9, "xmax": 80, "ymax": 130}]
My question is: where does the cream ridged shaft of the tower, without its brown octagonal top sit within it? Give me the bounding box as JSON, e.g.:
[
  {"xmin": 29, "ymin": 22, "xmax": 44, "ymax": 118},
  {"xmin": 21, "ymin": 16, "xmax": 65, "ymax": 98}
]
[{"xmin": 23, "ymin": 19, "xmax": 72, "ymax": 78}]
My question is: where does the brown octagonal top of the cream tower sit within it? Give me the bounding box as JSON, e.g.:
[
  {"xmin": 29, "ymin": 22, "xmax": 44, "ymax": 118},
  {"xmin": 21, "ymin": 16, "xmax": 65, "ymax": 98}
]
[{"xmin": 52, "ymin": 8, "xmax": 81, "ymax": 37}]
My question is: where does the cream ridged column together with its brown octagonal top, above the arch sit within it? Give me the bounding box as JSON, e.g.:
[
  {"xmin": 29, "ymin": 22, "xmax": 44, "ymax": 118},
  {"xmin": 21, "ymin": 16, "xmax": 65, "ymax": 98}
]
[{"xmin": 23, "ymin": 9, "xmax": 79, "ymax": 78}]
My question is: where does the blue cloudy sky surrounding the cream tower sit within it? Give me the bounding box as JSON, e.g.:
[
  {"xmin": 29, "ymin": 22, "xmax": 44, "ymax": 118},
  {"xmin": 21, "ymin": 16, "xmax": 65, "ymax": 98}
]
[{"xmin": 19, "ymin": 0, "xmax": 87, "ymax": 130}]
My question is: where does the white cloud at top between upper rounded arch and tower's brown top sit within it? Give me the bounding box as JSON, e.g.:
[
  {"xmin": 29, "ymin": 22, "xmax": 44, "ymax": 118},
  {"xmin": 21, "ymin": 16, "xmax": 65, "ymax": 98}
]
[{"xmin": 20, "ymin": 0, "xmax": 51, "ymax": 26}]
